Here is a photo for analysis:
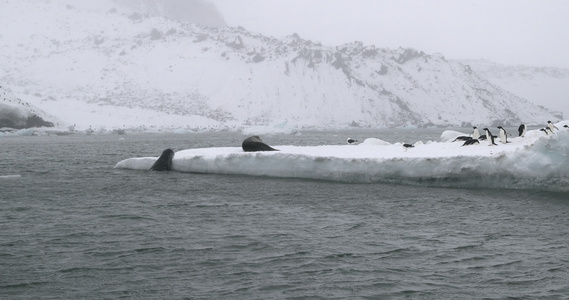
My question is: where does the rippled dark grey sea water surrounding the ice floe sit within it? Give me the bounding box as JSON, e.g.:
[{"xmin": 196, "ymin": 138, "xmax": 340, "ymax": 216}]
[{"xmin": 0, "ymin": 130, "xmax": 569, "ymax": 299}]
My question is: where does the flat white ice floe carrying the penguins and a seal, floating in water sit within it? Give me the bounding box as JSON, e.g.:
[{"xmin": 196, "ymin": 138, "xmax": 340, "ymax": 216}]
[{"xmin": 115, "ymin": 129, "xmax": 569, "ymax": 191}]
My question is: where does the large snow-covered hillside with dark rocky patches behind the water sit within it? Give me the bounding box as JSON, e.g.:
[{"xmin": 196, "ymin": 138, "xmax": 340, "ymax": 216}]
[{"xmin": 0, "ymin": 0, "xmax": 562, "ymax": 128}]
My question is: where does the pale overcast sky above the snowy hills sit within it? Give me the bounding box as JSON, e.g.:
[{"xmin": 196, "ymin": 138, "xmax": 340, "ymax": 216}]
[{"xmin": 212, "ymin": 0, "xmax": 569, "ymax": 68}]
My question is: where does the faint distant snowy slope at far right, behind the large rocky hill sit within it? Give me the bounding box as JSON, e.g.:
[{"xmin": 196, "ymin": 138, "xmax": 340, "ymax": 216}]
[{"xmin": 461, "ymin": 60, "xmax": 569, "ymax": 116}]
